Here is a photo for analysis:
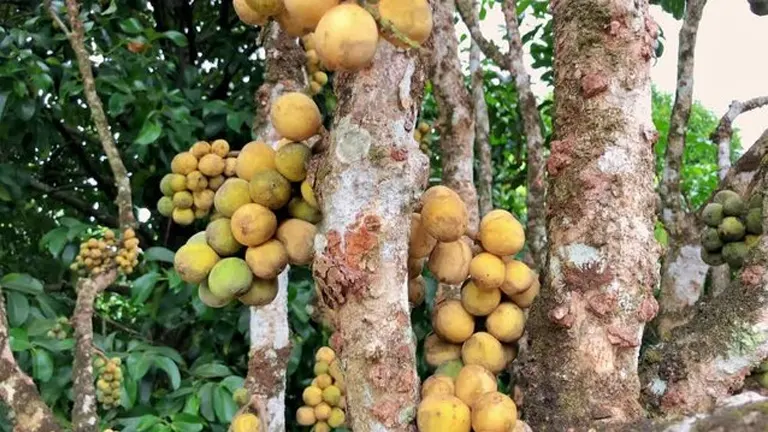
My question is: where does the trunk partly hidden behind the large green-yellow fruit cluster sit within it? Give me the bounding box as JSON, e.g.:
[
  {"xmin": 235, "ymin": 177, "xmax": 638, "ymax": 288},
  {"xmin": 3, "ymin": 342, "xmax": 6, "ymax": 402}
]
[{"xmin": 246, "ymin": 24, "xmax": 306, "ymax": 432}]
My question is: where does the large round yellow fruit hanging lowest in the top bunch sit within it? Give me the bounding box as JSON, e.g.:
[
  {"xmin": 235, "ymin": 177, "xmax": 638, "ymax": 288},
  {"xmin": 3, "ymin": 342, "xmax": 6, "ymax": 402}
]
[{"xmin": 314, "ymin": 3, "xmax": 379, "ymax": 71}]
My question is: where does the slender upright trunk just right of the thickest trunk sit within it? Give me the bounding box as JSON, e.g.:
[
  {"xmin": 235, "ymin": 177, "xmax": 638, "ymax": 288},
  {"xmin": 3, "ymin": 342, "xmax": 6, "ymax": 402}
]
[{"xmin": 657, "ymin": 0, "xmax": 709, "ymax": 337}]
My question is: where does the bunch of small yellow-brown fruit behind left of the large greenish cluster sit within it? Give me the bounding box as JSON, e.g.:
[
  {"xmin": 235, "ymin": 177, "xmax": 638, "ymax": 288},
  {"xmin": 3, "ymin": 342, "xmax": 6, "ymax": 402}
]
[{"xmin": 157, "ymin": 139, "xmax": 236, "ymax": 225}]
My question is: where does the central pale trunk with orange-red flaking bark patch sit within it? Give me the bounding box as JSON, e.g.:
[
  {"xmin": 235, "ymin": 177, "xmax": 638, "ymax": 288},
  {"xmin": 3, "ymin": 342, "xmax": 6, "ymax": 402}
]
[{"xmin": 313, "ymin": 41, "xmax": 428, "ymax": 432}]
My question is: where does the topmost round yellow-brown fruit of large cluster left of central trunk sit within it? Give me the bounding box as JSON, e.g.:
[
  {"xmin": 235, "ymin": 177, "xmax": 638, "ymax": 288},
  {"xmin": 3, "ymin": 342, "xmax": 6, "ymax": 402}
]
[{"xmin": 269, "ymin": 92, "xmax": 322, "ymax": 142}]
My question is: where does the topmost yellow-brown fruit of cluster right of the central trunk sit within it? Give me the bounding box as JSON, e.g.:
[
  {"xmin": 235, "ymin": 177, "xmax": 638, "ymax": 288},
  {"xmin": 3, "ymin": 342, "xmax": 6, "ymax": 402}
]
[{"xmin": 421, "ymin": 186, "xmax": 469, "ymax": 242}]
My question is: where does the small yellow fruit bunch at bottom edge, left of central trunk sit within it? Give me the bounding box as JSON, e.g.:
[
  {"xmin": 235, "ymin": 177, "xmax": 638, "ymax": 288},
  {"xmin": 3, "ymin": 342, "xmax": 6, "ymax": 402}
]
[{"xmin": 296, "ymin": 346, "xmax": 346, "ymax": 432}]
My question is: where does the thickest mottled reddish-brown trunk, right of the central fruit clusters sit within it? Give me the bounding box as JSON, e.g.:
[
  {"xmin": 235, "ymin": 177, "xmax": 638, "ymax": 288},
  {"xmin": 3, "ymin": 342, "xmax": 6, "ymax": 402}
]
[{"xmin": 525, "ymin": 0, "xmax": 659, "ymax": 431}]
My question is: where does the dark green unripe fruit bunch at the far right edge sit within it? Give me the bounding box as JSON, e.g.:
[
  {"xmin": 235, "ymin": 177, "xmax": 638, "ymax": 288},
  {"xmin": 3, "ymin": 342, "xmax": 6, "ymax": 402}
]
[{"xmin": 701, "ymin": 190, "xmax": 763, "ymax": 269}]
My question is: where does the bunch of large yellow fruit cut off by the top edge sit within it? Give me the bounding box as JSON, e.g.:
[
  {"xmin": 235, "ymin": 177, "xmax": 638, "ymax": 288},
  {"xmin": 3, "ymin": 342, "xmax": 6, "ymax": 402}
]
[{"xmin": 234, "ymin": 0, "xmax": 432, "ymax": 71}]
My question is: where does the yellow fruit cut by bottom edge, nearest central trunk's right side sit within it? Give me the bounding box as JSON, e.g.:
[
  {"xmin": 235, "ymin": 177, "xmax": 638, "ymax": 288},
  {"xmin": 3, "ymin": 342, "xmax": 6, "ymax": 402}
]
[{"xmin": 416, "ymin": 395, "xmax": 471, "ymax": 432}]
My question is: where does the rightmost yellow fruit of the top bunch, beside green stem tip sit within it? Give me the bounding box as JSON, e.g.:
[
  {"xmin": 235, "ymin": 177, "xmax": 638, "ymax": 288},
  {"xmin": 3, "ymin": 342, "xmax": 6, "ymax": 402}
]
[{"xmin": 379, "ymin": 0, "xmax": 432, "ymax": 48}]
